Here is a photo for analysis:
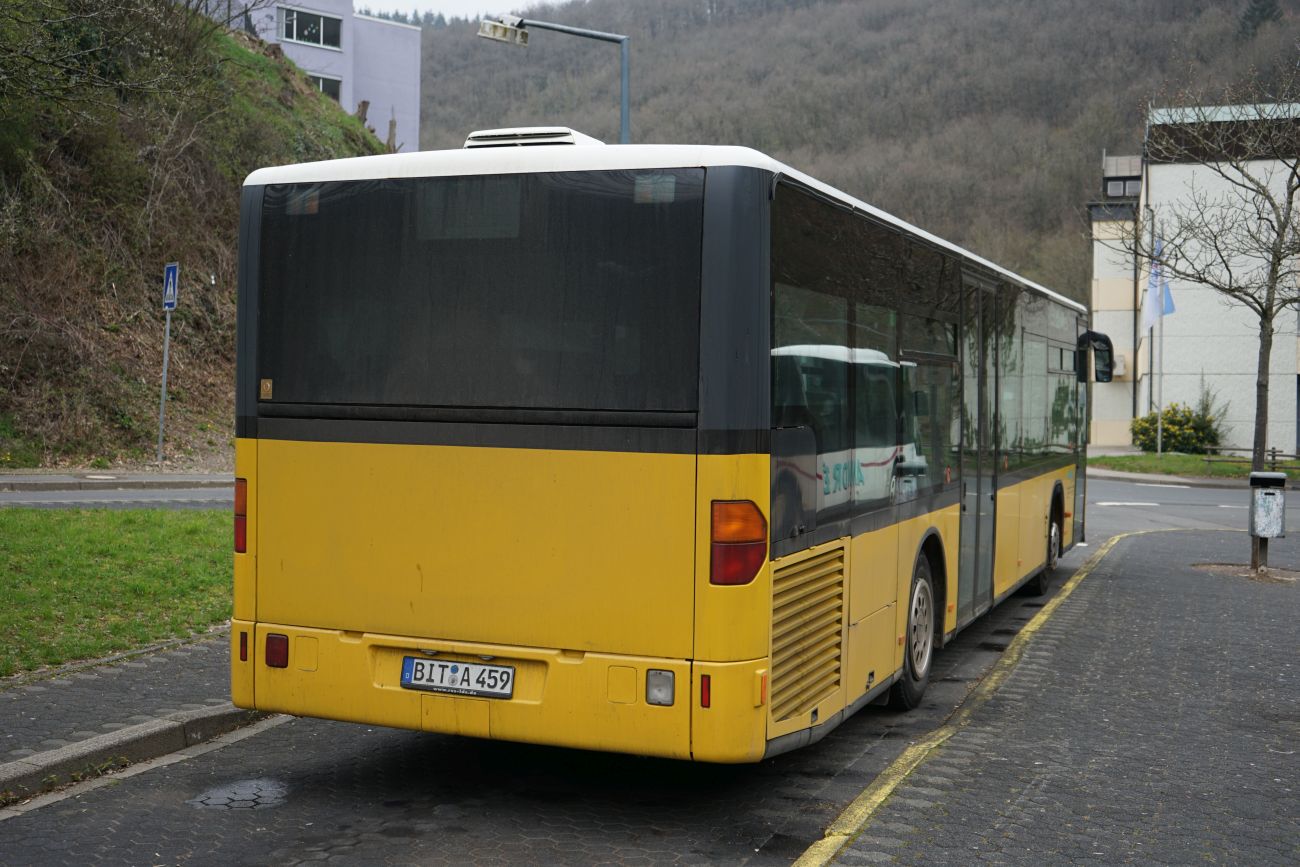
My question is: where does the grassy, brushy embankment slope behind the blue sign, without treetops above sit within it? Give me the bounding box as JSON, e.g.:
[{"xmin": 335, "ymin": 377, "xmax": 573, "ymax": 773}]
[{"xmin": 0, "ymin": 34, "xmax": 382, "ymax": 468}]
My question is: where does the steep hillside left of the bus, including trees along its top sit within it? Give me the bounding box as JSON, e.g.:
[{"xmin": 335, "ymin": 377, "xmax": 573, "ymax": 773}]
[{"xmin": 0, "ymin": 0, "xmax": 382, "ymax": 468}]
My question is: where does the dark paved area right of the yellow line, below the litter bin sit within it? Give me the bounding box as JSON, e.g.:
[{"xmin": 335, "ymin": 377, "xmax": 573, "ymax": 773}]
[{"xmin": 839, "ymin": 532, "xmax": 1300, "ymax": 866}]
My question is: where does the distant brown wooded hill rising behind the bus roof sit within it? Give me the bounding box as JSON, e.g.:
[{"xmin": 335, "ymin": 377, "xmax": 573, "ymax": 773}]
[{"xmin": 421, "ymin": 0, "xmax": 1300, "ymax": 300}]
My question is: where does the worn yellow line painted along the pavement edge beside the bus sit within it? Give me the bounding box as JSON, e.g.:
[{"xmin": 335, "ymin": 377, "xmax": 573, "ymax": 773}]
[{"xmin": 794, "ymin": 528, "xmax": 1184, "ymax": 867}]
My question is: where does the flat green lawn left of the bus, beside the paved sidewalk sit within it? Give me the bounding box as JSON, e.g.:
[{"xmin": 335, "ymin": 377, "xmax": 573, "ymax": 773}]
[{"xmin": 0, "ymin": 508, "xmax": 231, "ymax": 676}]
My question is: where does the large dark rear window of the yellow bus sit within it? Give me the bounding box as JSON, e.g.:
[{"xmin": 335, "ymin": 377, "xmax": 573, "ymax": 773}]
[{"xmin": 257, "ymin": 169, "xmax": 705, "ymax": 412}]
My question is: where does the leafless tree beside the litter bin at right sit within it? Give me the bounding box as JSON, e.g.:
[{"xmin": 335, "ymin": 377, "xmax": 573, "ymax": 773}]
[{"xmin": 1121, "ymin": 61, "xmax": 1300, "ymax": 568}]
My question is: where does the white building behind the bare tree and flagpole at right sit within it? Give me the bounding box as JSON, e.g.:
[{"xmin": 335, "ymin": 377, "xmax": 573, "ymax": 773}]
[{"xmin": 1089, "ymin": 107, "xmax": 1300, "ymax": 452}]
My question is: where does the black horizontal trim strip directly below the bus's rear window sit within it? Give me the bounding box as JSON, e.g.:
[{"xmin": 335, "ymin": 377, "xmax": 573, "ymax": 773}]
[{"xmin": 256, "ymin": 416, "xmax": 696, "ymax": 455}]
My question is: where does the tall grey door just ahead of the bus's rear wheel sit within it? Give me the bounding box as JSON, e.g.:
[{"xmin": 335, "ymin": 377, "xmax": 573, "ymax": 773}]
[{"xmin": 957, "ymin": 276, "xmax": 997, "ymax": 624}]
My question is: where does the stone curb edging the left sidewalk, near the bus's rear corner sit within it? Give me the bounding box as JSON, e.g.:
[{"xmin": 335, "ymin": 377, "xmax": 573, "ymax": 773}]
[{"xmin": 0, "ymin": 705, "xmax": 267, "ymax": 805}]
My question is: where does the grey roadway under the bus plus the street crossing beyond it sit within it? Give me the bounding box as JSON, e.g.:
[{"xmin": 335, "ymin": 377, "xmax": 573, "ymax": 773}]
[{"xmin": 0, "ymin": 480, "xmax": 1289, "ymax": 864}]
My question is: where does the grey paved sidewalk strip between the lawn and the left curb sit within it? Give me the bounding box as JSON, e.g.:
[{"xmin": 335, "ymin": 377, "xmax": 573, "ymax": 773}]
[{"xmin": 0, "ymin": 632, "xmax": 230, "ymax": 764}]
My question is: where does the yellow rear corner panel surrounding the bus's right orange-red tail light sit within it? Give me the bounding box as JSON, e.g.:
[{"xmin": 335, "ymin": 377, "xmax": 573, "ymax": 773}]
[{"xmin": 694, "ymin": 455, "xmax": 772, "ymax": 662}]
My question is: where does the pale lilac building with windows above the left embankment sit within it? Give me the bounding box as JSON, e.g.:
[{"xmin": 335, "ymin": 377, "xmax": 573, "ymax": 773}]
[{"xmin": 230, "ymin": 0, "xmax": 420, "ymax": 152}]
